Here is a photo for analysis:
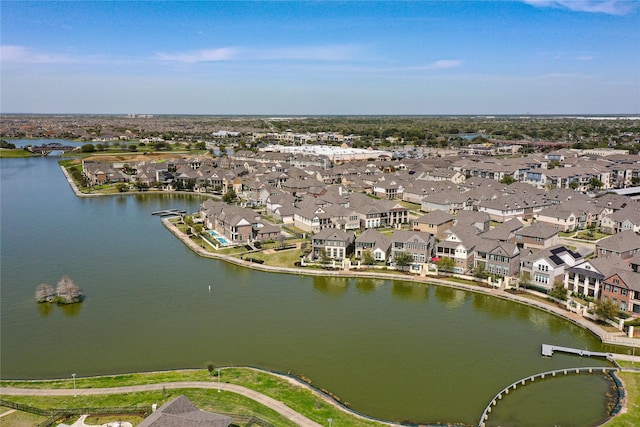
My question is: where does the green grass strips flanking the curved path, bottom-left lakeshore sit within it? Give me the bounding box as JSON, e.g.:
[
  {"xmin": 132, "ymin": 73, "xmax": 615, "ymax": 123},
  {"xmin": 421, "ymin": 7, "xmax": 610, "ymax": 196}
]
[{"xmin": 0, "ymin": 368, "xmax": 381, "ymax": 427}]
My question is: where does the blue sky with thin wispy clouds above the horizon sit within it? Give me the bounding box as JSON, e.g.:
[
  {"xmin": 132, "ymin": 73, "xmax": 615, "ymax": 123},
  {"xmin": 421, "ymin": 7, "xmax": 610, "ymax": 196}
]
[{"xmin": 0, "ymin": 0, "xmax": 640, "ymax": 115}]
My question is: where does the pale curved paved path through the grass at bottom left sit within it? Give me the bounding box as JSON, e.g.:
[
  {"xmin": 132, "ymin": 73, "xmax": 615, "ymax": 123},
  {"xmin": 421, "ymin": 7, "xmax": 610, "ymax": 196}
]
[{"xmin": 0, "ymin": 381, "xmax": 322, "ymax": 427}]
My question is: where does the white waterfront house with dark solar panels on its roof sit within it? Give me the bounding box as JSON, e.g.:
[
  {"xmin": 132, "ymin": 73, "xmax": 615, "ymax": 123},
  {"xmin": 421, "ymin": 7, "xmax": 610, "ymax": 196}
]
[{"xmin": 520, "ymin": 245, "xmax": 583, "ymax": 291}]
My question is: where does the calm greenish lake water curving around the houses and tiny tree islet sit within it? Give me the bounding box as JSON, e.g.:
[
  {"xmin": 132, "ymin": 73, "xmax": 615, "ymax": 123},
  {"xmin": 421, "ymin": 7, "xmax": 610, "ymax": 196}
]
[{"xmin": 0, "ymin": 145, "xmax": 620, "ymax": 427}]
